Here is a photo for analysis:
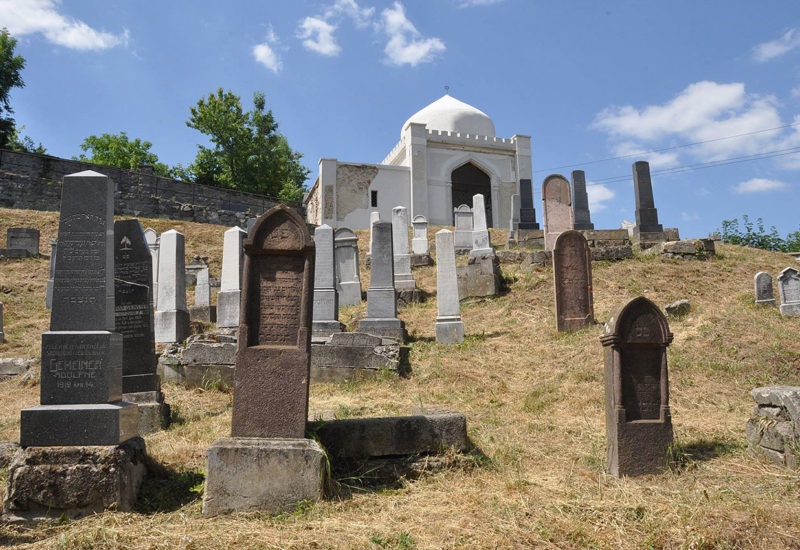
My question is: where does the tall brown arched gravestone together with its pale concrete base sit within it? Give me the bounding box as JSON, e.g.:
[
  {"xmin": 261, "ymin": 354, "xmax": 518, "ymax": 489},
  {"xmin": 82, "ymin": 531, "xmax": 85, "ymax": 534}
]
[{"xmin": 203, "ymin": 205, "xmax": 324, "ymax": 515}]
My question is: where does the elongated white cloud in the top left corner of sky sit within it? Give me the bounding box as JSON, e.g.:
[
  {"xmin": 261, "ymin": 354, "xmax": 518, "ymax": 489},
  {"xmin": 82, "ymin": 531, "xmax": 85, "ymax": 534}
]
[{"xmin": 0, "ymin": 0, "xmax": 130, "ymax": 50}]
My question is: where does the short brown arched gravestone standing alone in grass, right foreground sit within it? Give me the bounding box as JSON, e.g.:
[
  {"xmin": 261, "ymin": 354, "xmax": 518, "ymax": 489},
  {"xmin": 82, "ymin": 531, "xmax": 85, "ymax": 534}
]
[{"xmin": 600, "ymin": 297, "xmax": 672, "ymax": 477}]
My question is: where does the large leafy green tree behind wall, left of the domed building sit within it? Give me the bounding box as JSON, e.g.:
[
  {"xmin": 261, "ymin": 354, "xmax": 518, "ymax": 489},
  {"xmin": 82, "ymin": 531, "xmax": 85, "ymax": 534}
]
[{"xmin": 186, "ymin": 88, "xmax": 309, "ymax": 202}]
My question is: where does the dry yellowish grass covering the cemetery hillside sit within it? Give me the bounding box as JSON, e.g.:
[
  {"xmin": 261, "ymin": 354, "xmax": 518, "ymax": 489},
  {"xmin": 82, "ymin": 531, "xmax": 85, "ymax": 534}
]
[{"xmin": 0, "ymin": 211, "xmax": 800, "ymax": 549}]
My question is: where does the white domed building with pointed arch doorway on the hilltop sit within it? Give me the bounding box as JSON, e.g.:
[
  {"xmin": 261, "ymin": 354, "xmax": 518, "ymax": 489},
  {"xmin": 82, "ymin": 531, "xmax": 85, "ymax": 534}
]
[{"xmin": 305, "ymin": 95, "xmax": 532, "ymax": 229}]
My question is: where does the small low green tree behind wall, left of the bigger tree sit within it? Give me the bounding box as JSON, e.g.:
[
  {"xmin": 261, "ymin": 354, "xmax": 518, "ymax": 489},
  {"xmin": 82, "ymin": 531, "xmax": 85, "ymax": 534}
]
[{"xmin": 73, "ymin": 132, "xmax": 172, "ymax": 177}]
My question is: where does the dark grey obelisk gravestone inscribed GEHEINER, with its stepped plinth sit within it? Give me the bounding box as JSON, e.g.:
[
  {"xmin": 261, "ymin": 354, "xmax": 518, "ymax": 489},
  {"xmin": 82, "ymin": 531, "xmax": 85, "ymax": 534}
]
[{"xmin": 20, "ymin": 171, "xmax": 138, "ymax": 447}]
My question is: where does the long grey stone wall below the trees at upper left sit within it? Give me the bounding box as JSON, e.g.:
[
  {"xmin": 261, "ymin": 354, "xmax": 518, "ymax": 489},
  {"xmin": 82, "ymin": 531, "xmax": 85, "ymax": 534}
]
[{"xmin": 0, "ymin": 149, "xmax": 305, "ymax": 226}]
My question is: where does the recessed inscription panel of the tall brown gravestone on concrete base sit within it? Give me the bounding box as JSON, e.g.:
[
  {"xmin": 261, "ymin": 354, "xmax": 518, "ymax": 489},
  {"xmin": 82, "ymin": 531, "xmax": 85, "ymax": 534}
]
[{"xmin": 251, "ymin": 256, "xmax": 305, "ymax": 346}]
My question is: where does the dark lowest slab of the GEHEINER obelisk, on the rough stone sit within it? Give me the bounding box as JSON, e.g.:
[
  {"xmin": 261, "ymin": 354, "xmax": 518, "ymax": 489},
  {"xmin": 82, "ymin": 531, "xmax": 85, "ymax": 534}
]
[{"xmin": 20, "ymin": 401, "xmax": 139, "ymax": 447}]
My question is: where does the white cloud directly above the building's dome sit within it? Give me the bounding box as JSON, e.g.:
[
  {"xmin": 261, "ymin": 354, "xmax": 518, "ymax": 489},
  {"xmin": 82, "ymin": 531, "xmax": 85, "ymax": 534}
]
[{"xmin": 381, "ymin": 2, "xmax": 445, "ymax": 67}]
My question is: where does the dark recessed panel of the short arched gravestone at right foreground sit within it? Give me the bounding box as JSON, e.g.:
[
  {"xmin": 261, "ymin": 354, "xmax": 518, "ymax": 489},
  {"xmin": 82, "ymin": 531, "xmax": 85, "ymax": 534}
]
[{"xmin": 622, "ymin": 348, "xmax": 662, "ymax": 421}]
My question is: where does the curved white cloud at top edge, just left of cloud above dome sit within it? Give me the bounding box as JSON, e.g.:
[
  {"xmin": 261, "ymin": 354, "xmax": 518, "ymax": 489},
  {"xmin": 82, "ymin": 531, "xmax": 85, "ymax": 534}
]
[{"xmin": 297, "ymin": 0, "xmax": 375, "ymax": 57}]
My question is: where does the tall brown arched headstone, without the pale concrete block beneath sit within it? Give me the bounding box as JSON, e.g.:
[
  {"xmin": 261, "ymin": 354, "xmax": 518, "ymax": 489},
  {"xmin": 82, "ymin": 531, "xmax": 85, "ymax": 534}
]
[{"xmin": 231, "ymin": 205, "xmax": 314, "ymax": 438}]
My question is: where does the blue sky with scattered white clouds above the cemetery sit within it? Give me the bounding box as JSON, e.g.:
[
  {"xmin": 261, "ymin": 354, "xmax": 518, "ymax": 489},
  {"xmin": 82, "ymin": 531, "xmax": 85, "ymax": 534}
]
[{"xmin": 0, "ymin": 0, "xmax": 800, "ymax": 237}]
